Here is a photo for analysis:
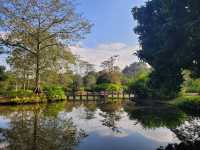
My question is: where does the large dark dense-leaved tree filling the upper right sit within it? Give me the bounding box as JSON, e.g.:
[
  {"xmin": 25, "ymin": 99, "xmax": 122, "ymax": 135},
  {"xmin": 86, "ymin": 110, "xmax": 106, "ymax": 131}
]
[{"xmin": 132, "ymin": 0, "xmax": 200, "ymax": 96}]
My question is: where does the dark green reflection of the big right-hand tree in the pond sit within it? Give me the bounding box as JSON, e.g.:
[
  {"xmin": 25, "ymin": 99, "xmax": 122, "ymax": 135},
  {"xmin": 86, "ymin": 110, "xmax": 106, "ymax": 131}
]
[{"xmin": 125, "ymin": 101, "xmax": 187, "ymax": 128}]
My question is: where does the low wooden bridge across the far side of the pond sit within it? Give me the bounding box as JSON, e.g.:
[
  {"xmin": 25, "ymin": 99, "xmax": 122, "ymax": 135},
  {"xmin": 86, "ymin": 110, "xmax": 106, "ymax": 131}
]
[{"xmin": 67, "ymin": 91, "xmax": 134, "ymax": 101}]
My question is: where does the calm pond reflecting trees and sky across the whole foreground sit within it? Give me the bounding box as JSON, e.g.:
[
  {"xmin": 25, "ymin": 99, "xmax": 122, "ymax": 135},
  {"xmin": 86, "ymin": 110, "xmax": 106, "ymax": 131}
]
[{"xmin": 0, "ymin": 101, "xmax": 200, "ymax": 150}]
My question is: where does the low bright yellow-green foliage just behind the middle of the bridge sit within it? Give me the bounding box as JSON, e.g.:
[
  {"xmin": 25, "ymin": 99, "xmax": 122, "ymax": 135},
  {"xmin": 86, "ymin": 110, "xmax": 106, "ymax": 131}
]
[{"xmin": 95, "ymin": 83, "xmax": 122, "ymax": 92}]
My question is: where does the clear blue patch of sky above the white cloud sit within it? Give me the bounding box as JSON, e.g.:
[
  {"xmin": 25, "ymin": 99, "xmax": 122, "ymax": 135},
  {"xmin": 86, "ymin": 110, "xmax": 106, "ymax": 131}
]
[{"xmin": 78, "ymin": 0, "xmax": 144, "ymax": 47}]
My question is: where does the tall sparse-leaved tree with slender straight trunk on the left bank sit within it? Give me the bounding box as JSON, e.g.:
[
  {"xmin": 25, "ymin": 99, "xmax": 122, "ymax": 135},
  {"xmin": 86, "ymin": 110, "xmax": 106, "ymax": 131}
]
[{"xmin": 0, "ymin": 0, "xmax": 91, "ymax": 93}]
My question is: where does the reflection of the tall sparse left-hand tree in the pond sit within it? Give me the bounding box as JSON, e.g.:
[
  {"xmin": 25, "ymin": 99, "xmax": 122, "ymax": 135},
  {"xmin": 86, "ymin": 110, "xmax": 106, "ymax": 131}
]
[{"xmin": 0, "ymin": 106, "xmax": 87, "ymax": 150}]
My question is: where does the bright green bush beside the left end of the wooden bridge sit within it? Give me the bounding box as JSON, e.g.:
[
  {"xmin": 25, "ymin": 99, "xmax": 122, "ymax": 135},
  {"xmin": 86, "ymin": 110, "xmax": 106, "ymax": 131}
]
[{"xmin": 44, "ymin": 86, "xmax": 66, "ymax": 101}]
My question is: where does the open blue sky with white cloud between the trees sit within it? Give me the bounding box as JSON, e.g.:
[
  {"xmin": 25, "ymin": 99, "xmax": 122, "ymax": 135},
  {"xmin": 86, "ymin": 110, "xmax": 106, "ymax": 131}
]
[{"xmin": 0, "ymin": 0, "xmax": 145, "ymax": 70}]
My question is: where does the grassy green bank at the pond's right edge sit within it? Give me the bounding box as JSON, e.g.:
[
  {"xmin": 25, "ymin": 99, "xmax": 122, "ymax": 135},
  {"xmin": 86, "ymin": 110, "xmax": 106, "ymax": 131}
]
[{"xmin": 169, "ymin": 95, "xmax": 200, "ymax": 113}]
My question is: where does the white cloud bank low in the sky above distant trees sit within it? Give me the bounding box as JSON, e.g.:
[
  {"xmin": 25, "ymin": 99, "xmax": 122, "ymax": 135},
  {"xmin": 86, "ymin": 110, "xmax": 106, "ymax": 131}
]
[{"xmin": 71, "ymin": 43, "xmax": 138, "ymax": 70}]
